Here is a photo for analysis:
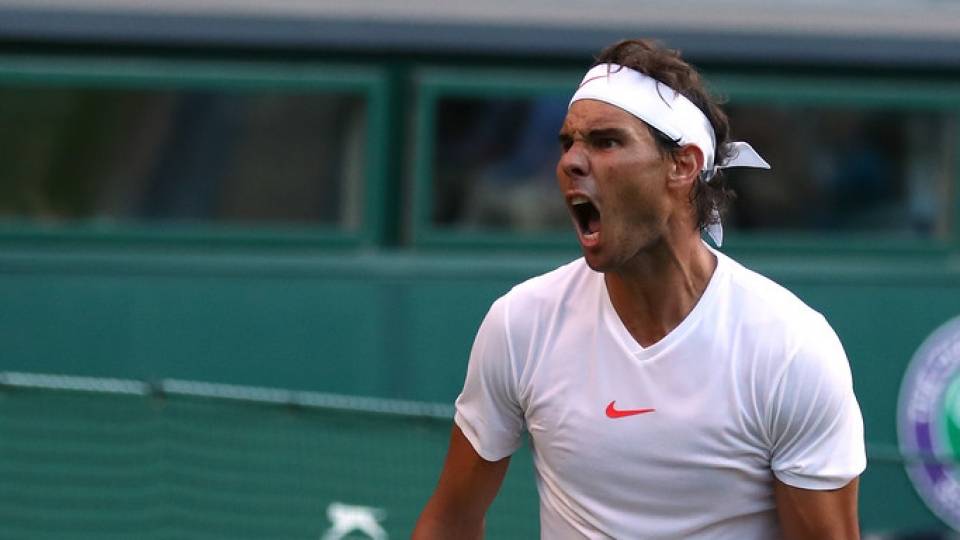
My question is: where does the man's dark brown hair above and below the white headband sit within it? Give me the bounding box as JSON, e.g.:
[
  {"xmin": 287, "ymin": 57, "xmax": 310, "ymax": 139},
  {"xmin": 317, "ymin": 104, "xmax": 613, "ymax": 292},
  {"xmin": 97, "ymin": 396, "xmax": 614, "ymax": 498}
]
[{"xmin": 593, "ymin": 39, "xmax": 735, "ymax": 230}]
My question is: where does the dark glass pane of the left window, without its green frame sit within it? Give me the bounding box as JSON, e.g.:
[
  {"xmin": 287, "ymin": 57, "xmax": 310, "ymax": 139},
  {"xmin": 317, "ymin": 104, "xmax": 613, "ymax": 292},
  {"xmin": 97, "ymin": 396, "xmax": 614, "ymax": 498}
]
[{"xmin": 0, "ymin": 86, "xmax": 366, "ymax": 229}]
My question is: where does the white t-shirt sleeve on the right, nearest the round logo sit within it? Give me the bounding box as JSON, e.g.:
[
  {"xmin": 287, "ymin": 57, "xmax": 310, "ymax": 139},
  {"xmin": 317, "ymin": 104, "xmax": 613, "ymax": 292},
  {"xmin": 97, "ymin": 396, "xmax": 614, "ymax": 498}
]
[{"xmin": 768, "ymin": 316, "xmax": 866, "ymax": 490}]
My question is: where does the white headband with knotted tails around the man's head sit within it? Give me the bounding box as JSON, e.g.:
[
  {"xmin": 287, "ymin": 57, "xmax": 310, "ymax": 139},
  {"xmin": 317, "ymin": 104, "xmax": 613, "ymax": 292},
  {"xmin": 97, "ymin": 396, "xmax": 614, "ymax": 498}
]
[{"xmin": 570, "ymin": 64, "xmax": 770, "ymax": 247}]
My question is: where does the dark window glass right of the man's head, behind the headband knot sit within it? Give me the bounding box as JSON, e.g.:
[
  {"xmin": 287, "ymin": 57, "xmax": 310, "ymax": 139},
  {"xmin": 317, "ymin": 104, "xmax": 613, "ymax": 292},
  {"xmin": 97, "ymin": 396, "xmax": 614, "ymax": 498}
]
[{"xmin": 726, "ymin": 105, "xmax": 956, "ymax": 236}]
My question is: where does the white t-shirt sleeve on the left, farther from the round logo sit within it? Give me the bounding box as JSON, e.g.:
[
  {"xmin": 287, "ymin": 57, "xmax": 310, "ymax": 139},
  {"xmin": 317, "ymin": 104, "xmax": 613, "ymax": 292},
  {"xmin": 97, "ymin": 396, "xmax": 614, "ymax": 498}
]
[{"xmin": 454, "ymin": 298, "xmax": 523, "ymax": 461}]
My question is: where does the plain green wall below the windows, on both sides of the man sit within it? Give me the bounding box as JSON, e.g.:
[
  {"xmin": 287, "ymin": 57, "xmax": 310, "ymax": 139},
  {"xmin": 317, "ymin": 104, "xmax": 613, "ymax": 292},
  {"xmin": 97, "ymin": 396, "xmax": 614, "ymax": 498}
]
[{"xmin": 0, "ymin": 247, "xmax": 960, "ymax": 531}]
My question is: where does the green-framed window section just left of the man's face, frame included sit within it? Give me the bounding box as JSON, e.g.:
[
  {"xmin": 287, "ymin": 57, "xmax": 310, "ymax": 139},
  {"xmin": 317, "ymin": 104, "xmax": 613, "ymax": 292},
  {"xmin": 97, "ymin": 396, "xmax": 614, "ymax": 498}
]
[{"xmin": 410, "ymin": 69, "xmax": 576, "ymax": 247}]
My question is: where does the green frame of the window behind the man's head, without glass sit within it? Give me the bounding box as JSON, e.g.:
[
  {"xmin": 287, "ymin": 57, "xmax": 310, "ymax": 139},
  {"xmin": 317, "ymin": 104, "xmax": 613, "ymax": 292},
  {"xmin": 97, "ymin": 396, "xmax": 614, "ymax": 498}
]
[{"xmin": 410, "ymin": 67, "xmax": 960, "ymax": 255}]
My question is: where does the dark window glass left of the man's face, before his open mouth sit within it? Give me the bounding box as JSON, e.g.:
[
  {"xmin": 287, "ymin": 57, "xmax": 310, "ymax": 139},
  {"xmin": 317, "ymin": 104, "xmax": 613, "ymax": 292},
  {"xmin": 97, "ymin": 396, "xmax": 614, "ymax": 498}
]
[{"xmin": 433, "ymin": 96, "xmax": 570, "ymax": 232}]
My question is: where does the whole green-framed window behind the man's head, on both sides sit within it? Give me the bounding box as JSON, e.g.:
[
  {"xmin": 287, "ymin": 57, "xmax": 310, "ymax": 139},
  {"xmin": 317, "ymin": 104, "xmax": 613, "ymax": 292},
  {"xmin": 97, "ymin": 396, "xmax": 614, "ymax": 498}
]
[{"xmin": 414, "ymin": 71, "xmax": 960, "ymax": 248}]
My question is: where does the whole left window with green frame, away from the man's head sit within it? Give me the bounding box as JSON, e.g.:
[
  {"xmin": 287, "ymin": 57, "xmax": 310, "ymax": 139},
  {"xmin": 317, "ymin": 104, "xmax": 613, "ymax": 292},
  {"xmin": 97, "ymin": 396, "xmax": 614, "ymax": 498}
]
[{"xmin": 0, "ymin": 60, "xmax": 383, "ymax": 245}]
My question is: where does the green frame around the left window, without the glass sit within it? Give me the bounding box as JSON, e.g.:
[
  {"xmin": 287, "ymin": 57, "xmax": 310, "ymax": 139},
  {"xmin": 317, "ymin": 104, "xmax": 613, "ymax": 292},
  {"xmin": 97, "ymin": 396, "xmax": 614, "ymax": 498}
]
[{"xmin": 0, "ymin": 54, "xmax": 389, "ymax": 247}]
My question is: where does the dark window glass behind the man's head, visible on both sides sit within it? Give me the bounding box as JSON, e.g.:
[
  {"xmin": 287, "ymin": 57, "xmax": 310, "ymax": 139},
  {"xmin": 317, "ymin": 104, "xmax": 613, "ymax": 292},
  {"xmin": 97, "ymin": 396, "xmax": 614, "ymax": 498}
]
[{"xmin": 431, "ymin": 90, "xmax": 957, "ymax": 236}]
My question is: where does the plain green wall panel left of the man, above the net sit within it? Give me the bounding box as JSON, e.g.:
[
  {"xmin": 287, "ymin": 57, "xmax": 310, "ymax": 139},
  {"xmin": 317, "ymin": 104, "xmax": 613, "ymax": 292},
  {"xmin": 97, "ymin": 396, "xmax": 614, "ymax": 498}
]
[{"xmin": 0, "ymin": 252, "xmax": 564, "ymax": 401}]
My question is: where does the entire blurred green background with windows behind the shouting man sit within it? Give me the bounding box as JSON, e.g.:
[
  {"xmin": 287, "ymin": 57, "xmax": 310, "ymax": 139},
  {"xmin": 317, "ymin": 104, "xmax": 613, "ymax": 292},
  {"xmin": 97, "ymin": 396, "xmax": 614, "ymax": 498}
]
[{"xmin": 0, "ymin": 0, "xmax": 960, "ymax": 540}]
